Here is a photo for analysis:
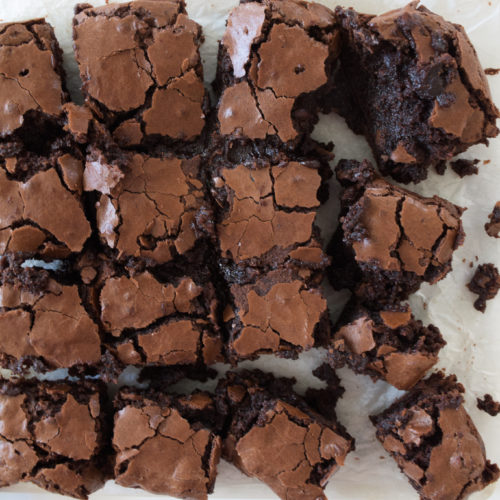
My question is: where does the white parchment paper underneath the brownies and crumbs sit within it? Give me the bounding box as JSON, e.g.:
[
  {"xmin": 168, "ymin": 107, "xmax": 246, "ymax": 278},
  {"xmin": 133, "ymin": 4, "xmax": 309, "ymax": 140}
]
[{"xmin": 0, "ymin": 0, "xmax": 500, "ymax": 500}]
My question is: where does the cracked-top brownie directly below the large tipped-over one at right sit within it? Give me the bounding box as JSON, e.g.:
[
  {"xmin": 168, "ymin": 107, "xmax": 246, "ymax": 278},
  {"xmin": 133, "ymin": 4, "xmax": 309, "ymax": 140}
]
[{"xmin": 329, "ymin": 160, "xmax": 464, "ymax": 307}]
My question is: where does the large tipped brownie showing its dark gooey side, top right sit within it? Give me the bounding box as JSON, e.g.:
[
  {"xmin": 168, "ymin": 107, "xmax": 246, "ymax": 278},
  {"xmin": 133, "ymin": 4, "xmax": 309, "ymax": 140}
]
[{"xmin": 331, "ymin": 2, "xmax": 499, "ymax": 183}]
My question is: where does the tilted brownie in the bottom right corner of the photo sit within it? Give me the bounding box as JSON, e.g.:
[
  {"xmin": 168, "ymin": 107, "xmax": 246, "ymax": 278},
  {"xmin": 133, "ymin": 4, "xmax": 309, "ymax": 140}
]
[{"xmin": 370, "ymin": 372, "xmax": 500, "ymax": 500}]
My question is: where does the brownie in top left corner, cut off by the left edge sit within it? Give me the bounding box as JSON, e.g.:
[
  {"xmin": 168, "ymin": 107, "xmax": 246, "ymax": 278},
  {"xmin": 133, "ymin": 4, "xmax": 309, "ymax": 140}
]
[{"xmin": 0, "ymin": 19, "xmax": 69, "ymax": 159}]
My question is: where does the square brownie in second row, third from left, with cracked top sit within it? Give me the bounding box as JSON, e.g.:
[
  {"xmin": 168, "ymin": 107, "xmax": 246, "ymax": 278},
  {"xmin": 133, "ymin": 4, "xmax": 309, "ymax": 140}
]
[{"xmin": 209, "ymin": 152, "xmax": 330, "ymax": 274}]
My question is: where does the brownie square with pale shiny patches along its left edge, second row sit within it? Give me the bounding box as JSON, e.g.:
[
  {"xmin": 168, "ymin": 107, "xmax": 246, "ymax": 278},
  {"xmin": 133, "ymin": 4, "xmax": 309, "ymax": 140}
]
[{"xmin": 83, "ymin": 146, "xmax": 213, "ymax": 265}]
